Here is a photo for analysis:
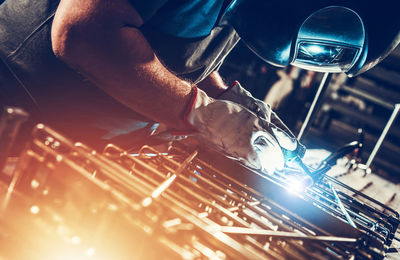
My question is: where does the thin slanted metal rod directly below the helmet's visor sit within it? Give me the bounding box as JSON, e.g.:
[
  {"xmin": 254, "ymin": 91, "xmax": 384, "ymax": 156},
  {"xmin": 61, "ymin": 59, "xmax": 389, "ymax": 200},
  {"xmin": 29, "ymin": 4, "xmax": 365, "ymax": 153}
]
[{"xmin": 297, "ymin": 72, "xmax": 331, "ymax": 142}]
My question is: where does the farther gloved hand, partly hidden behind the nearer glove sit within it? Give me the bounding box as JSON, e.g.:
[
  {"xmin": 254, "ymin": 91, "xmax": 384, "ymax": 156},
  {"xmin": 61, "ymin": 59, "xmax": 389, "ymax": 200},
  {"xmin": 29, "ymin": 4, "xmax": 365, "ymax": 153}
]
[{"xmin": 218, "ymin": 81, "xmax": 306, "ymax": 161}]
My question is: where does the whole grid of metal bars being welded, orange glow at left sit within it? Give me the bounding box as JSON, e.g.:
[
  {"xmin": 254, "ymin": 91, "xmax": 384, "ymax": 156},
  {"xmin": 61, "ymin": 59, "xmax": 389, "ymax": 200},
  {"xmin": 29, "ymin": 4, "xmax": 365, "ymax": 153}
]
[{"xmin": 0, "ymin": 125, "xmax": 398, "ymax": 260}]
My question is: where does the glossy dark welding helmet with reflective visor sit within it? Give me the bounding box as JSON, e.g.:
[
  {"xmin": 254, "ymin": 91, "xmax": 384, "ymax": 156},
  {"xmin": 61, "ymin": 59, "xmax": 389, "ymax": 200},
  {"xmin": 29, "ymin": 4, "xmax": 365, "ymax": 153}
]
[{"xmin": 221, "ymin": 0, "xmax": 400, "ymax": 76}]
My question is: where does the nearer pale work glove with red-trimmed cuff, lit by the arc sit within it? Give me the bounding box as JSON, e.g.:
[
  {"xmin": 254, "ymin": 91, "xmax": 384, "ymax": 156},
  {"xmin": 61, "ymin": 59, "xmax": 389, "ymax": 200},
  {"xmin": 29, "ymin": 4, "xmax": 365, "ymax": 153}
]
[{"xmin": 185, "ymin": 87, "xmax": 284, "ymax": 174}]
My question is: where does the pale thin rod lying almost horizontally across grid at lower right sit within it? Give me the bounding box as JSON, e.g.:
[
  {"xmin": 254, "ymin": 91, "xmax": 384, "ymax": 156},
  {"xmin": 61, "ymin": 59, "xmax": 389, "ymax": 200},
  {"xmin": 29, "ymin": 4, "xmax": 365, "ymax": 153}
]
[{"xmin": 215, "ymin": 226, "xmax": 357, "ymax": 243}]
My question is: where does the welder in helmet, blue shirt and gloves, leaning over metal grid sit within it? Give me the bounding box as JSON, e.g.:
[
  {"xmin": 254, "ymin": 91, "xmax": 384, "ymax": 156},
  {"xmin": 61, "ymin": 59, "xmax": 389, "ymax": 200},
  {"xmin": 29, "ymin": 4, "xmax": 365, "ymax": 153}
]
[{"xmin": 0, "ymin": 0, "xmax": 399, "ymax": 172}]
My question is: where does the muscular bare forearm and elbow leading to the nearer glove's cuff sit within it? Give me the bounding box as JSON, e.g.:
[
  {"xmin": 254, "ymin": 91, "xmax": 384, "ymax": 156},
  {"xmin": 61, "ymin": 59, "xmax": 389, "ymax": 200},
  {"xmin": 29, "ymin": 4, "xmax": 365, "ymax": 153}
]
[{"xmin": 51, "ymin": 0, "xmax": 191, "ymax": 130}]
